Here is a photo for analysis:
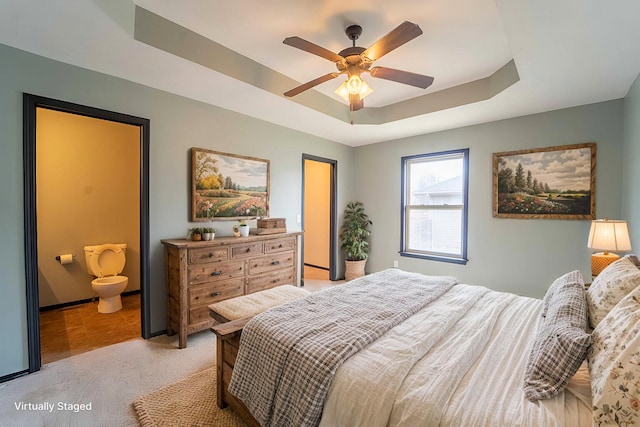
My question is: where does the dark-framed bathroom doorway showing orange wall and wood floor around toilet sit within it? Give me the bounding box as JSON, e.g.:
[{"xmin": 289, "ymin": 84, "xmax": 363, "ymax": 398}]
[{"xmin": 24, "ymin": 94, "xmax": 150, "ymax": 372}]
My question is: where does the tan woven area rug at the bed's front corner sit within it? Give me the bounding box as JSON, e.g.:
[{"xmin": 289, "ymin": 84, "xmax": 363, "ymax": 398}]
[{"xmin": 133, "ymin": 367, "xmax": 246, "ymax": 427}]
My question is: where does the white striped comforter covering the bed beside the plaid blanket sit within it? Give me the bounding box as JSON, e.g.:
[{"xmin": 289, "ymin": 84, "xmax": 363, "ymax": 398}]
[{"xmin": 320, "ymin": 285, "xmax": 591, "ymax": 427}]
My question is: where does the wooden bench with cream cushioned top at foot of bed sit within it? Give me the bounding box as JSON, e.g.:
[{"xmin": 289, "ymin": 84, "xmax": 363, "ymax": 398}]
[{"xmin": 209, "ymin": 285, "xmax": 310, "ymax": 427}]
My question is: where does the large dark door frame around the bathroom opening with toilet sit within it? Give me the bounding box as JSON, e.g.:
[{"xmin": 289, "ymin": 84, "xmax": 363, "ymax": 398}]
[{"xmin": 23, "ymin": 93, "xmax": 151, "ymax": 373}]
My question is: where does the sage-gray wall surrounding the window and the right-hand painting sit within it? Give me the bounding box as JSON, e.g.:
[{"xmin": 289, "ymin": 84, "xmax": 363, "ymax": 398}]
[{"xmin": 355, "ymin": 100, "xmax": 623, "ymax": 297}]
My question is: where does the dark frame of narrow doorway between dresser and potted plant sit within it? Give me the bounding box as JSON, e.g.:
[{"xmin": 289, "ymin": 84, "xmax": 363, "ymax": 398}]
[{"xmin": 301, "ymin": 153, "xmax": 338, "ymax": 284}]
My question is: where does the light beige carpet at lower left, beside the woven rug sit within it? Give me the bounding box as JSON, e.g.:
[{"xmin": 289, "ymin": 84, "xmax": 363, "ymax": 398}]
[{"xmin": 0, "ymin": 330, "xmax": 216, "ymax": 427}]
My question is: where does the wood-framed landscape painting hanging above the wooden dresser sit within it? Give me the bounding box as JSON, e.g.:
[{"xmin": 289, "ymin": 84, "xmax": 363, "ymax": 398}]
[{"xmin": 191, "ymin": 148, "xmax": 269, "ymax": 222}]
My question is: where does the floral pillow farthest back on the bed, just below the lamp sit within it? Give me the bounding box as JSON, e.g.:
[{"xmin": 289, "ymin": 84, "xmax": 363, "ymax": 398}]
[{"xmin": 587, "ymin": 255, "xmax": 640, "ymax": 328}]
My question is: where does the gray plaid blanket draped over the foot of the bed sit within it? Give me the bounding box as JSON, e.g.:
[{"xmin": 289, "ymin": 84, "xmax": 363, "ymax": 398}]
[{"xmin": 229, "ymin": 269, "xmax": 457, "ymax": 427}]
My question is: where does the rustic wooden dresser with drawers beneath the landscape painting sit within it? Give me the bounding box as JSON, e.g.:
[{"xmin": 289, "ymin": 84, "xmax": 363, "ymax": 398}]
[{"xmin": 162, "ymin": 232, "xmax": 301, "ymax": 348}]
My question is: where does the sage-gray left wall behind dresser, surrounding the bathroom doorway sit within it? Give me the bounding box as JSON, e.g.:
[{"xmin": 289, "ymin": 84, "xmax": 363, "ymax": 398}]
[{"xmin": 0, "ymin": 45, "xmax": 353, "ymax": 377}]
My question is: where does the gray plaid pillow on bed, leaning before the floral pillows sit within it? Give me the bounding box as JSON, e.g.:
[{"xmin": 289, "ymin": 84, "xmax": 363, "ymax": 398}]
[{"xmin": 524, "ymin": 270, "xmax": 591, "ymax": 402}]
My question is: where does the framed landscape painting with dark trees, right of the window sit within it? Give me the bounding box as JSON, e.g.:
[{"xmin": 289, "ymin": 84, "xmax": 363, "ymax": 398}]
[{"xmin": 493, "ymin": 142, "xmax": 596, "ymax": 220}]
